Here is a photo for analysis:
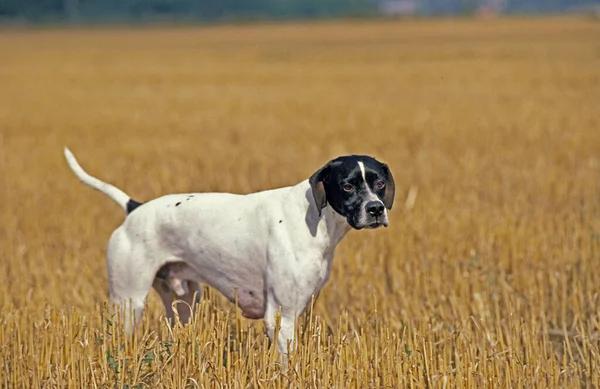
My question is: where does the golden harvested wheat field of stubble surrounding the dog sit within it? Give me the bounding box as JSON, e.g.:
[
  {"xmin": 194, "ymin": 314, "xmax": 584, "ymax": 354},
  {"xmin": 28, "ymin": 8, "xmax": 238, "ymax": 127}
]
[{"xmin": 0, "ymin": 17, "xmax": 600, "ymax": 388}]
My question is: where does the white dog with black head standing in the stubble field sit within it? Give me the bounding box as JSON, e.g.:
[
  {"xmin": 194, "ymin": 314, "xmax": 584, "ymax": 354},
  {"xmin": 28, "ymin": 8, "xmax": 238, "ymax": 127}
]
[{"xmin": 65, "ymin": 148, "xmax": 394, "ymax": 355}]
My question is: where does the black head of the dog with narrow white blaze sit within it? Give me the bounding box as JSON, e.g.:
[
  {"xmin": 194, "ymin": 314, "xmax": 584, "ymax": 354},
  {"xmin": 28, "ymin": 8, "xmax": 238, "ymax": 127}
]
[{"xmin": 309, "ymin": 155, "xmax": 395, "ymax": 230}]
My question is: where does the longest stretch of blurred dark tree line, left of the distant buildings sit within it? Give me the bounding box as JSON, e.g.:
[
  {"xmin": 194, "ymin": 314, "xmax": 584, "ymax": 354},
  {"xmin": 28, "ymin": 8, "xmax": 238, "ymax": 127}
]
[{"xmin": 0, "ymin": 0, "xmax": 375, "ymax": 21}]
